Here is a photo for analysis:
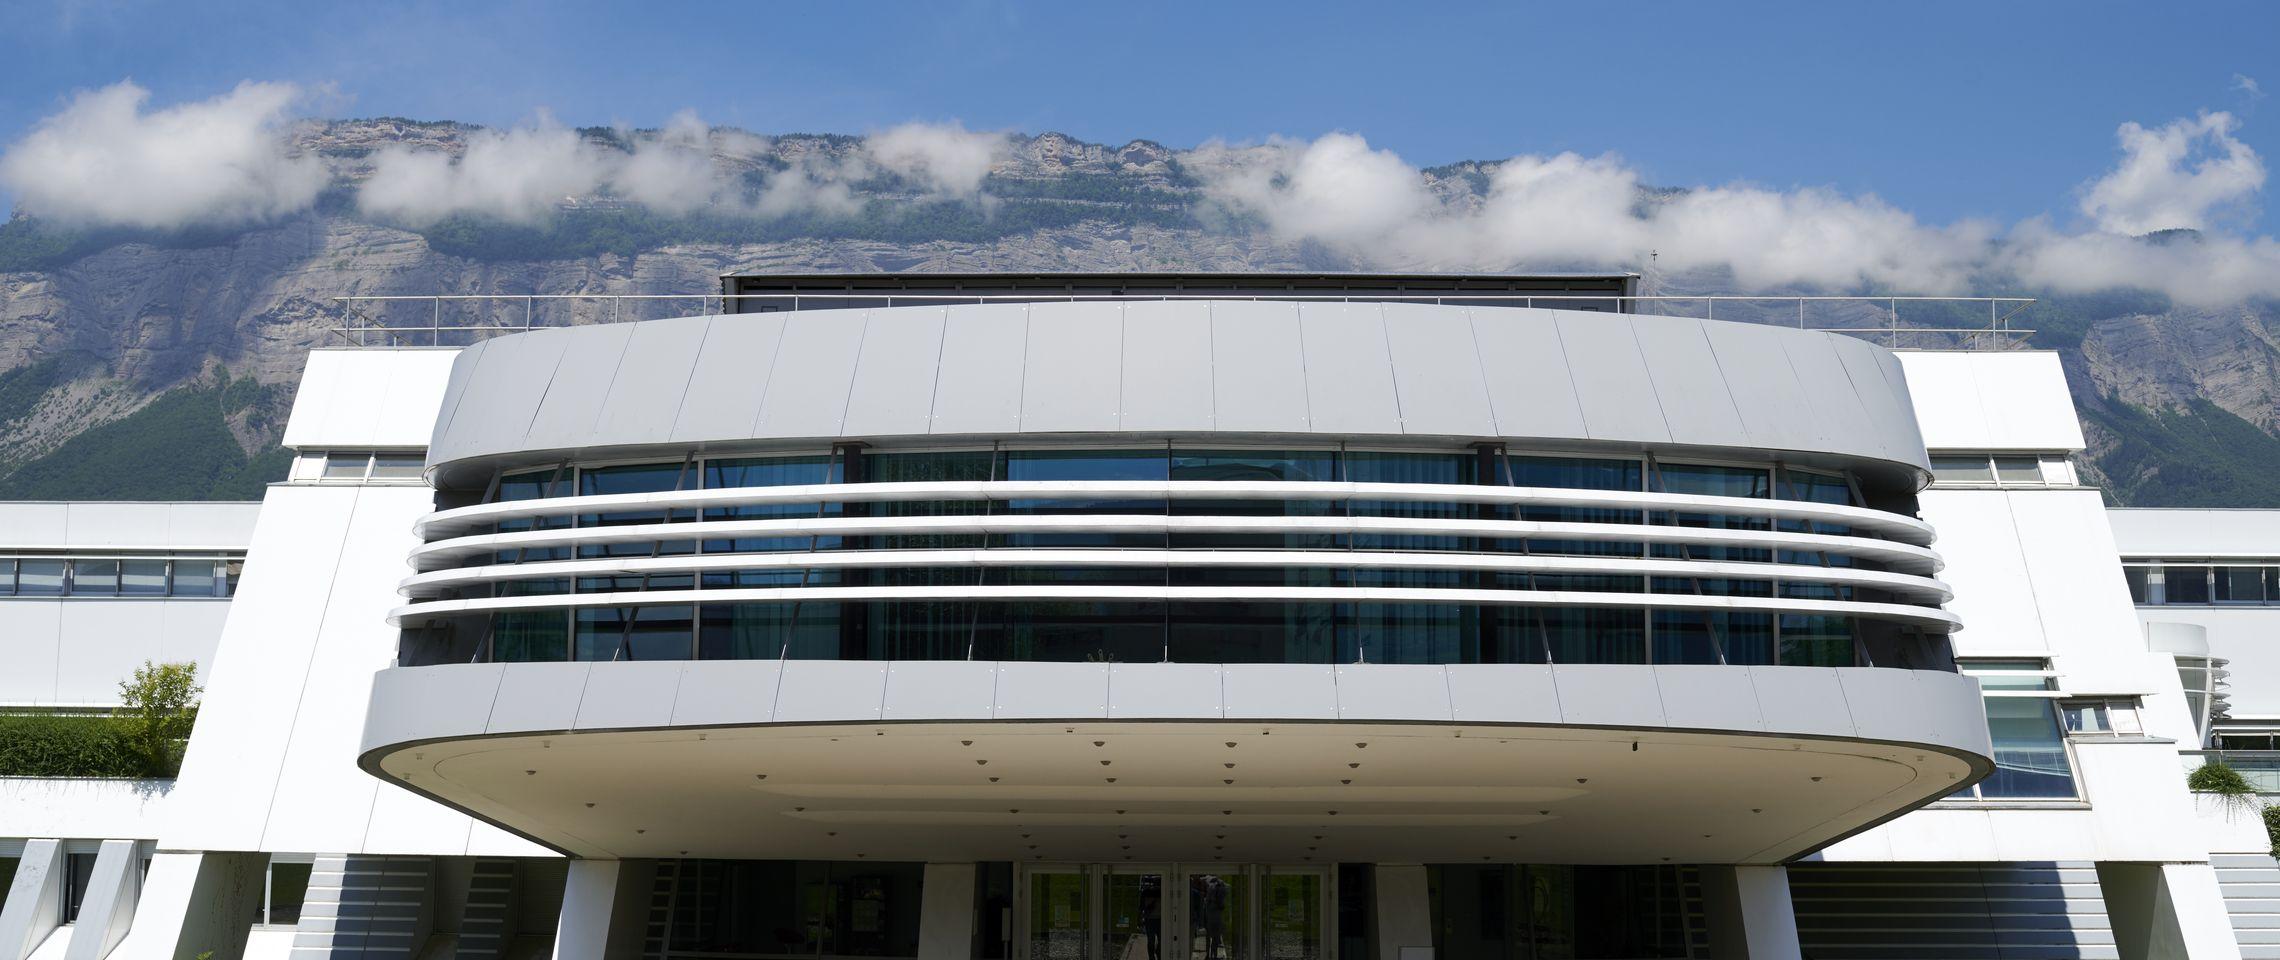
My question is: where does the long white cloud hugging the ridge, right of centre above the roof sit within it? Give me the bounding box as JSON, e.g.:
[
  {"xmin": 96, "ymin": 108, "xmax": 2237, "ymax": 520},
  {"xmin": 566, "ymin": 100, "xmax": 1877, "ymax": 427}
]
[{"xmin": 1195, "ymin": 132, "xmax": 1993, "ymax": 292}]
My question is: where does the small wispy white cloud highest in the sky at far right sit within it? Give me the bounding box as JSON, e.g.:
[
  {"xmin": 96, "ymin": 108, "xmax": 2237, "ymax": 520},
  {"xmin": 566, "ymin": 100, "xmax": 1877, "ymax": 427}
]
[{"xmin": 2082, "ymin": 112, "xmax": 2264, "ymax": 233}]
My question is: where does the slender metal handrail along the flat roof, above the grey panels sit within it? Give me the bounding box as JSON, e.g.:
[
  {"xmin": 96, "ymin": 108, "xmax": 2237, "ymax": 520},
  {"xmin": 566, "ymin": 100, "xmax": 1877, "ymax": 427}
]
[{"xmin": 331, "ymin": 290, "xmax": 2036, "ymax": 347}]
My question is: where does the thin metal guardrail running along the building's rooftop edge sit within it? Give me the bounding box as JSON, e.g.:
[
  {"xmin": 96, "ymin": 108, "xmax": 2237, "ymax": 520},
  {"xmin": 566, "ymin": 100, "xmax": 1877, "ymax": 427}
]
[{"xmin": 316, "ymin": 292, "xmax": 2034, "ymax": 349}]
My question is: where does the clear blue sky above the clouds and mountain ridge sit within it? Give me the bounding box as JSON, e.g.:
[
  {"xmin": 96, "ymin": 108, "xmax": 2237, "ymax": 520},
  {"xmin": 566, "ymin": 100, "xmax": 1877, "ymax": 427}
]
[{"xmin": 0, "ymin": 0, "xmax": 2280, "ymax": 230}]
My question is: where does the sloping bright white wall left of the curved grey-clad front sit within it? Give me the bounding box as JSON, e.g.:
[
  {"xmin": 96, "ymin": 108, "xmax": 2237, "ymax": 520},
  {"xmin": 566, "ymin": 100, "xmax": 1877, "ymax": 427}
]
[{"xmin": 160, "ymin": 351, "xmax": 549, "ymax": 855}]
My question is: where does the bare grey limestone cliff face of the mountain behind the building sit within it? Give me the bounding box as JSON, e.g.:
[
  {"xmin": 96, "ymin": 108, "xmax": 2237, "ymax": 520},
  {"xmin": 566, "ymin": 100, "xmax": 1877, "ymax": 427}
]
[{"xmin": 0, "ymin": 119, "xmax": 2280, "ymax": 504}]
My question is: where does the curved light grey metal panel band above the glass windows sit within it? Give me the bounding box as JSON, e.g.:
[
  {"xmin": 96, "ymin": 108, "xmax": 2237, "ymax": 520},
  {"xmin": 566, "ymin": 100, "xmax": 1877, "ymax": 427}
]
[{"xmin": 429, "ymin": 301, "xmax": 1929, "ymax": 472}]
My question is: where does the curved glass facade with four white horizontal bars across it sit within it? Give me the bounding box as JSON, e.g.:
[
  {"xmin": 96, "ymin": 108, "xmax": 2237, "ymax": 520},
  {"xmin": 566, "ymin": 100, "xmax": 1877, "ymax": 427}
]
[{"xmin": 401, "ymin": 445, "xmax": 1945, "ymax": 666}]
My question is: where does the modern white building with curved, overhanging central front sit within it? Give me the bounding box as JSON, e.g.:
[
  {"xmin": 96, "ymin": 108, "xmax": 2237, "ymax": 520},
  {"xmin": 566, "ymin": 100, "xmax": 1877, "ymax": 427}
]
[{"xmin": 0, "ymin": 276, "xmax": 2252, "ymax": 960}]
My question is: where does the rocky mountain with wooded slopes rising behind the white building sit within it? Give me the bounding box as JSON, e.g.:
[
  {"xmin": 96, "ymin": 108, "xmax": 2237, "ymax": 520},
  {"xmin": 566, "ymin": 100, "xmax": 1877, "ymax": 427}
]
[{"xmin": 0, "ymin": 119, "xmax": 2280, "ymax": 506}]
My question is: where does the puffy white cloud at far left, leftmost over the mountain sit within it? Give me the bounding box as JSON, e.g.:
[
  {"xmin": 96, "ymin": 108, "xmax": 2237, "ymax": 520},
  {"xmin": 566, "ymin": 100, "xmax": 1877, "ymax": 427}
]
[{"xmin": 0, "ymin": 80, "xmax": 328, "ymax": 230}]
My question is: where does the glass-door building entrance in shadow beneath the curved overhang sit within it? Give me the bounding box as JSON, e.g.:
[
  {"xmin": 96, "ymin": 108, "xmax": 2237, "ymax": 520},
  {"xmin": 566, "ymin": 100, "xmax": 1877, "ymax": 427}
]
[{"xmin": 1015, "ymin": 864, "xmax": 1338, "ymax": 960}]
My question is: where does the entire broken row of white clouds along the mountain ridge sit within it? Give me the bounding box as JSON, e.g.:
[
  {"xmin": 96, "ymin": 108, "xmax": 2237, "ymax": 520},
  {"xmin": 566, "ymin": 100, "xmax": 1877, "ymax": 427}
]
[{"xmin": 0, "ymin": 82, "xmax": 2280, "ymax": 303}]
